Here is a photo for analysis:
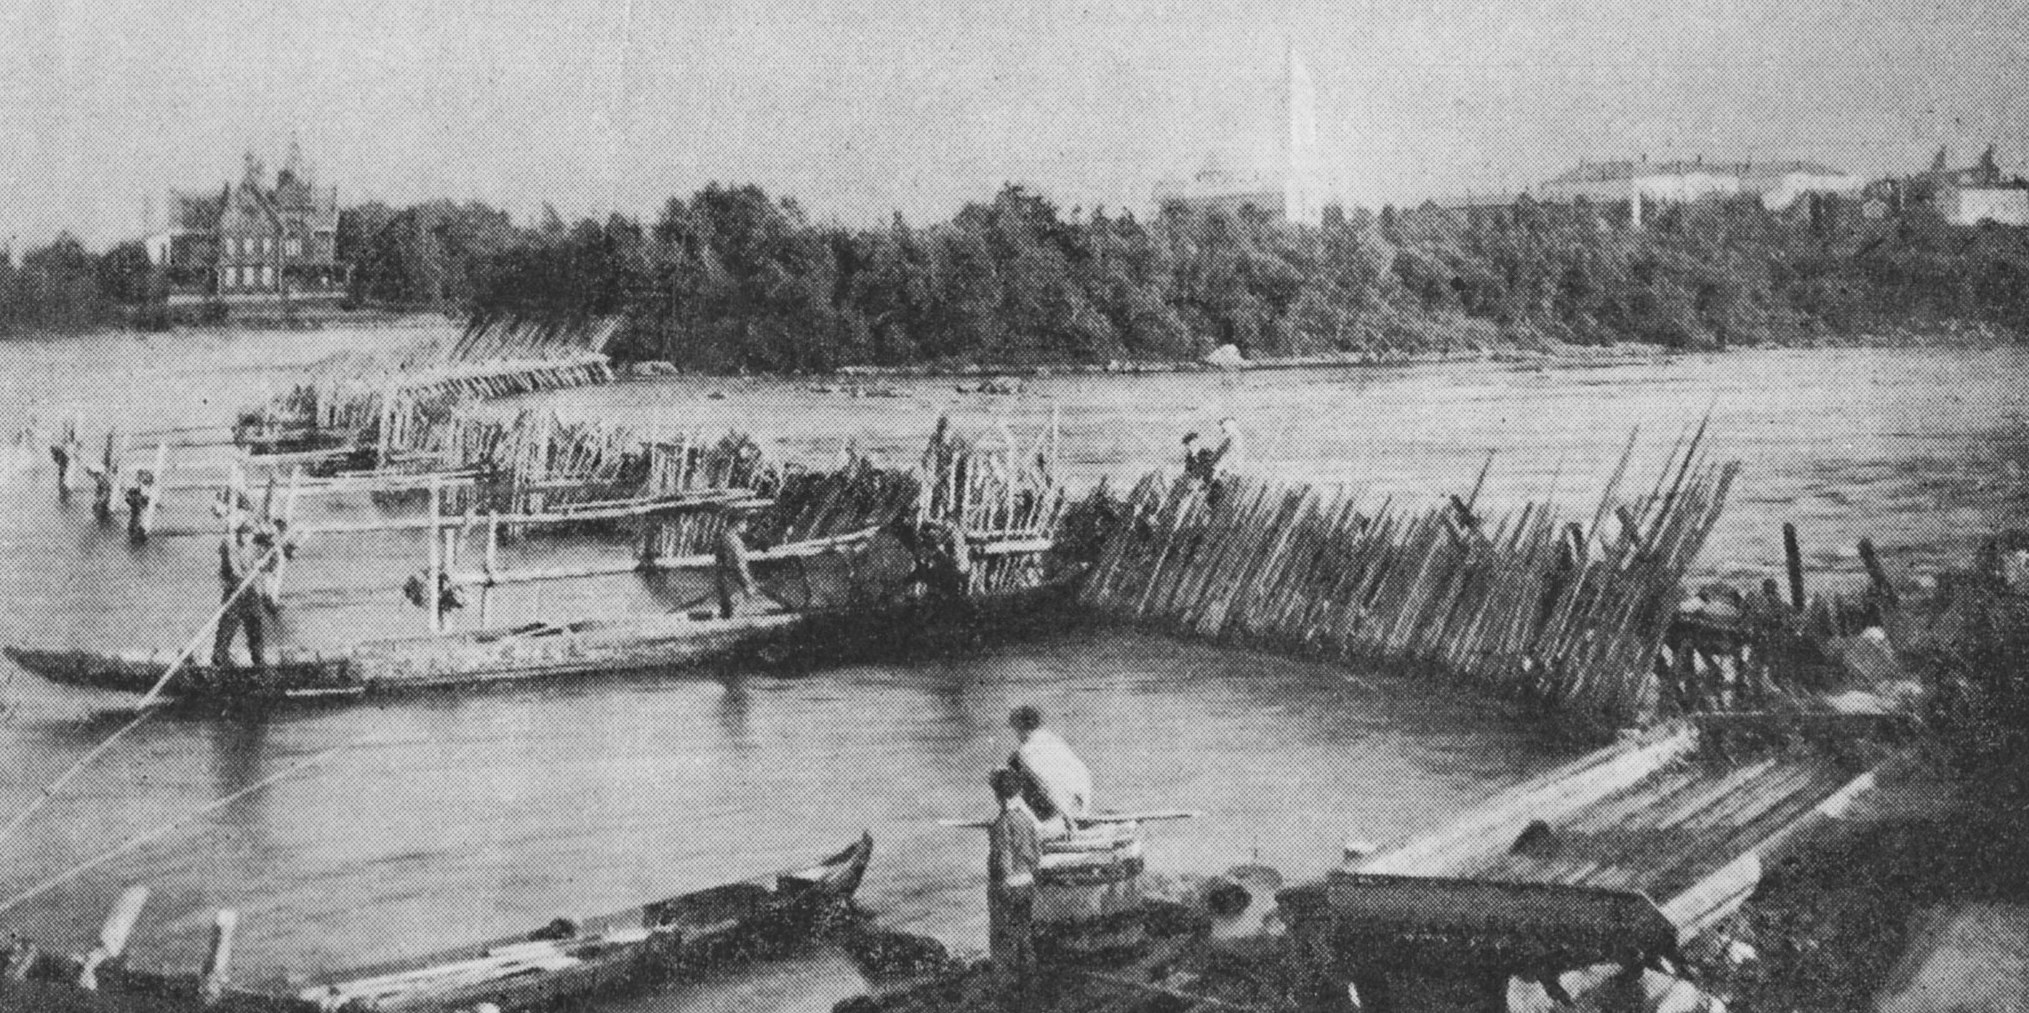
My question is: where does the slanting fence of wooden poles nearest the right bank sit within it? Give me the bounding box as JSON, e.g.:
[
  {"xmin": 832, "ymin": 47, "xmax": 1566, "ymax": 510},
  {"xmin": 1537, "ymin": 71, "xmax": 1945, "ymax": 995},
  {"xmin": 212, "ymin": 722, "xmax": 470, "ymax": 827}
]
[{"xmin": 1083, "ymin": 426, "xmax": 1739, "ymax": 731}]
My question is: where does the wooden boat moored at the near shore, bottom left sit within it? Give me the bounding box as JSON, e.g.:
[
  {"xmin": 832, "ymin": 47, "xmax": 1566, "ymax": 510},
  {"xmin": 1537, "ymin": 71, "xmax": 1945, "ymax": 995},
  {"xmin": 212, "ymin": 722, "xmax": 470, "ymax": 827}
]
[{"xmin": 0, "ymin": 836, "xmax": 872, "ymax": 1013}]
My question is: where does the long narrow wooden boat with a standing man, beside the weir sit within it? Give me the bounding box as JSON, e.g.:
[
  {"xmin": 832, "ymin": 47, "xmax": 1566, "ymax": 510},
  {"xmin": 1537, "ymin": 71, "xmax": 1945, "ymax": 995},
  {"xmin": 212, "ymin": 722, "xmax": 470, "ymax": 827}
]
[{"xmin": 6, "ymin": 581, "xmax": 1075, "ymax": 702}]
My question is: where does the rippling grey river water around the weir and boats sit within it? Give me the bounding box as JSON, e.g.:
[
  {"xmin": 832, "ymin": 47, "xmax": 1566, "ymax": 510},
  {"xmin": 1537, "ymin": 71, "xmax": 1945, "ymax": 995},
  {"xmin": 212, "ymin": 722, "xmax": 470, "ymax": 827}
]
[{"xmin": 0, "ymin": 331, "xmax": 2029, "ymax": 1009}]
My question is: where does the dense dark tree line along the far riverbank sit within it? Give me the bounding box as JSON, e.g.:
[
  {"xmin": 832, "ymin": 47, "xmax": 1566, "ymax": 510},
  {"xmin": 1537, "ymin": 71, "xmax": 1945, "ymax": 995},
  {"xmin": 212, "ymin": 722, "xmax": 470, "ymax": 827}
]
[{"xmin": 0, "ymin": 185, "xmax": 2029, "ymax": 372}]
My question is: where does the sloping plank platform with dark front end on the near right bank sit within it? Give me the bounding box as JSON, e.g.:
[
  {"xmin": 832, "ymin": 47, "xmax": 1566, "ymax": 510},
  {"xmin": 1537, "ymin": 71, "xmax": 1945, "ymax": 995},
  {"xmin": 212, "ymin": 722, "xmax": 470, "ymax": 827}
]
[{"xmin": 1282, "ymin": 723, "xmax": 1907, "ymax": 1011}]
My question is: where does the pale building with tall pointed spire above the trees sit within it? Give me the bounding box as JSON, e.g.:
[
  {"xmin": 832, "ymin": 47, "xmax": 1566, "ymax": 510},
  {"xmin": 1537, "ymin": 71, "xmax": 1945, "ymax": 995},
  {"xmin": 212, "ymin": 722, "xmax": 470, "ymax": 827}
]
[{"xmin": 1155, "ymin": 47, "xmax": 1327, "ymax": 225}]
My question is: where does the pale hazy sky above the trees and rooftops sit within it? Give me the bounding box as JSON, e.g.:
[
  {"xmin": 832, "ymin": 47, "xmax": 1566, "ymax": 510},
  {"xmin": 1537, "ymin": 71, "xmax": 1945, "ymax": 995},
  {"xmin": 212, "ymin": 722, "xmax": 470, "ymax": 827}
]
[{"xmin": 0, "ymin": 0, "xmax": 2029, "ymax": 244}]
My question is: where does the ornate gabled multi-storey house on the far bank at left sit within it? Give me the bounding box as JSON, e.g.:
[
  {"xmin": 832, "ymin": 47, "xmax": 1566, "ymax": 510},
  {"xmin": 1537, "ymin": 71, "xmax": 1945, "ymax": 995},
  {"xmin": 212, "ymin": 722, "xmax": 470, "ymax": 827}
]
[{"xmin": 146, "ymin": 144, "xmax": 347, "ymax": 302}]
